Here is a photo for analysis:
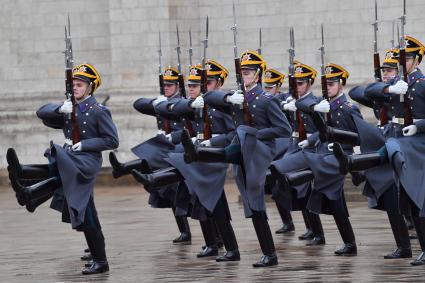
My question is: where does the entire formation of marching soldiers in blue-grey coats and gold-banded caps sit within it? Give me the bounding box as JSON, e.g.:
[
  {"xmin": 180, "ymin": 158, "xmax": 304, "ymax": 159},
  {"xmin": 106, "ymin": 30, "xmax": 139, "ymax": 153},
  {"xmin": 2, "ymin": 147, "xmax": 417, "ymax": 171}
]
[{"xmin": 7, "ymin": 31, "xmax": 425, "ymax": 274}]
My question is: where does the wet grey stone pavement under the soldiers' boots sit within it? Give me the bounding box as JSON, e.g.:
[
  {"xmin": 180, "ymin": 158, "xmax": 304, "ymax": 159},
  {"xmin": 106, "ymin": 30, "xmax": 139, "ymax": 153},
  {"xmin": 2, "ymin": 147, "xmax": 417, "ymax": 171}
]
[{"xmin": 0, "ymin": 186, "xmax": 424, "ymax": 282}]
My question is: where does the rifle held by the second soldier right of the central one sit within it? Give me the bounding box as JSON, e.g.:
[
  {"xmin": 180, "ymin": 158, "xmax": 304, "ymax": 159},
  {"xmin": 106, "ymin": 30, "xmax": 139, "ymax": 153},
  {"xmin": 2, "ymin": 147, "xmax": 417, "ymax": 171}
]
[{"xmin": 288, "ymin": 27, "xmax": 307, "ymax": 141}]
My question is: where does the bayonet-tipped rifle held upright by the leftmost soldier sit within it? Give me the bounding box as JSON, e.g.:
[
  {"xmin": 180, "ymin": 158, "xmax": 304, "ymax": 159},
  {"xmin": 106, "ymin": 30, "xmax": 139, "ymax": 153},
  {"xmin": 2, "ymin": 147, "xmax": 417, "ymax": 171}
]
[{"xmin": 64, "ymin": 15, "xmax": 80, "ymax": 144}]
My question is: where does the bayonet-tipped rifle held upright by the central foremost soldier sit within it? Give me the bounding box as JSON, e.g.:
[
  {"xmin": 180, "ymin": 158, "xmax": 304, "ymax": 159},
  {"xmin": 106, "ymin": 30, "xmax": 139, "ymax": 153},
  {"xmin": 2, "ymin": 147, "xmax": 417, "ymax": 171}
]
[{"xmin": 231, "ymin": 2, "xmax": 252, "ymax": 125}]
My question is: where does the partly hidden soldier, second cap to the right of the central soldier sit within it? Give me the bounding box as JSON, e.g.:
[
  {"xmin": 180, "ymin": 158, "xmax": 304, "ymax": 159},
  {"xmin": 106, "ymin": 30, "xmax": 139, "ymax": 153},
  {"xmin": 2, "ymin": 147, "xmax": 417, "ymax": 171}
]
[{"xmin": 271, "ymin": 61, "xmax": 328, "ymax": 245}]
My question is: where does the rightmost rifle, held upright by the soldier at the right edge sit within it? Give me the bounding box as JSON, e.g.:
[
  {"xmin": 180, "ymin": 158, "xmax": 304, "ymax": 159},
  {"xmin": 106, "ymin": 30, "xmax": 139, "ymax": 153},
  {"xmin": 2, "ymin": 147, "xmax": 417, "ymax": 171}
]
[{"xmin": 399, "ymin": 0, "xmax": 413, "ymax": 126}]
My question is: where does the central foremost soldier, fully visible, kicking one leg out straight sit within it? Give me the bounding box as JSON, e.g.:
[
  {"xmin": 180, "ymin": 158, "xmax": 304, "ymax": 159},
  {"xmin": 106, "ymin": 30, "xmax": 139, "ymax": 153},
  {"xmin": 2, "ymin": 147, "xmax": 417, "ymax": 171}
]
[{"xmin": 182, "ymin": 51, "xmax": 291, "ymax": 267}]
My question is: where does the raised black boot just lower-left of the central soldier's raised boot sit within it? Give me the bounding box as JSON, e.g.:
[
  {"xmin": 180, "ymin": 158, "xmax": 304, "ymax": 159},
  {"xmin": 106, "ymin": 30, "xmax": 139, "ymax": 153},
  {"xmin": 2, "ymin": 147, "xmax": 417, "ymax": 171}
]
[{"xmin": 131, "ymin": 167, "xmax": 183, "ymax": 188}]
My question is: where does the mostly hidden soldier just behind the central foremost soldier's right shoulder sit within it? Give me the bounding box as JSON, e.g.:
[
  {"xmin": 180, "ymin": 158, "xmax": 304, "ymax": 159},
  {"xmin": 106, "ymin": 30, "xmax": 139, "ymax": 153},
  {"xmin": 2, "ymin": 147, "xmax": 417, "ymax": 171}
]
[{"xmin": 263, "ymin": 68, "xmax": 295, "ymax": 234}]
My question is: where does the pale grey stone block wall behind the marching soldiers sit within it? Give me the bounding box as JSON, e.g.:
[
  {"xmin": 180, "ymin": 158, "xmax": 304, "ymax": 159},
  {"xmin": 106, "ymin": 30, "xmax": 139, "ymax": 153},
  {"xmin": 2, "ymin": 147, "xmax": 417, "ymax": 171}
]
[{"xmin": 0, "ymin": 0, "xmax": 425, "ymax": 168}]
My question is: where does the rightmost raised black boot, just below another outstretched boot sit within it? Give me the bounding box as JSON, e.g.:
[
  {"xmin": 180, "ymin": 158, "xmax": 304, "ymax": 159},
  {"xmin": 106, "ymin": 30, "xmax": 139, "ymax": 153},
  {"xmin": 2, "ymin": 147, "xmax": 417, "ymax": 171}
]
[{"xmin": 333, "ymin": 143, "xmax": 383, "ymax": 175}]
